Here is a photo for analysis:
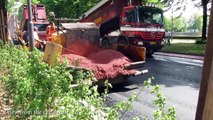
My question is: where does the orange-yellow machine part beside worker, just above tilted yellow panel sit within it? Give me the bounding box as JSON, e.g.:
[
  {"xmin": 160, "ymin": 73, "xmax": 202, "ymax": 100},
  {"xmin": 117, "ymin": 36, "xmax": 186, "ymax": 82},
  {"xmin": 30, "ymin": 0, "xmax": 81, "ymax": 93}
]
[{"xmin": 52, "ymin": 31, "xmax": 66, "ymax": 47}]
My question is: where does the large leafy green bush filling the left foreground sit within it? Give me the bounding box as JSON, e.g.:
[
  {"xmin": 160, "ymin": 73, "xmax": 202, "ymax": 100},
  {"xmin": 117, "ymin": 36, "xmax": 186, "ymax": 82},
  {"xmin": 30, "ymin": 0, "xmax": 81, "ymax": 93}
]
[{"xmin": 0, "ymin": 43, "xmax": 119, "ymax": 120}]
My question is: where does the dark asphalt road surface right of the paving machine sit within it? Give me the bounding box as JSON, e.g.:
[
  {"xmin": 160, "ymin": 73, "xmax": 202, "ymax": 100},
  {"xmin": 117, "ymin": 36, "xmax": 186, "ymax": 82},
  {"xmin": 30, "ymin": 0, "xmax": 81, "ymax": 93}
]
[{"xmin": 107, "ymin": 55, "xmax": 203, "ymax": 120}]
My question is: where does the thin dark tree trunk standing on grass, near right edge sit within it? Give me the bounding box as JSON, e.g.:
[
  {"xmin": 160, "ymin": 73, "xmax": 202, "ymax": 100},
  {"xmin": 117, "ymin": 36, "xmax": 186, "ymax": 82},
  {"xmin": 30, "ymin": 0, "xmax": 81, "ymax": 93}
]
[{"xmin": 202, "ymin": 2, "xmax": 208, "ymax": 41}]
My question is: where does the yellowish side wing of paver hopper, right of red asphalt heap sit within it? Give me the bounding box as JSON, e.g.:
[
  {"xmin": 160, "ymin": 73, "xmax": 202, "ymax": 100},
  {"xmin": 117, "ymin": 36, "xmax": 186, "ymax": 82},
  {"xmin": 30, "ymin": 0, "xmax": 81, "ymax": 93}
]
[{"xmin": 112, "ymin": 44, "xmax": 146, "ymax": 61}]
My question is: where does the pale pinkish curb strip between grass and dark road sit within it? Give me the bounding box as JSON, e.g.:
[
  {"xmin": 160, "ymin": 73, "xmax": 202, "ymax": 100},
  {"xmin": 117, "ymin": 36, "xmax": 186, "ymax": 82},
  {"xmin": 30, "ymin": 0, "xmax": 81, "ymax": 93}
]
[{"xmin": 154, "ymin": 52, "xmax": 204, "ymax": 60}]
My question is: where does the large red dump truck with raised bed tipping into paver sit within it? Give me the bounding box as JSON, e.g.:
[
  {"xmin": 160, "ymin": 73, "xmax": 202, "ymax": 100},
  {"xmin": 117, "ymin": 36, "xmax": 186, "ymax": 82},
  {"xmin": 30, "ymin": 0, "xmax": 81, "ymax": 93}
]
[{"xmin": 80, "ymin": 0, "xmax": 165, "ymax": 54}]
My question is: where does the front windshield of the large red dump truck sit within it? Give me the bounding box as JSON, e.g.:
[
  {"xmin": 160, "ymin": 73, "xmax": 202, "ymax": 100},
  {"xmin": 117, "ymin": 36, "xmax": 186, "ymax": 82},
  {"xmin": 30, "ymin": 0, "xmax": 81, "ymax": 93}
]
[{"xmin": 138, "ymin": 7, "xmax": 163, "ymax": 24}]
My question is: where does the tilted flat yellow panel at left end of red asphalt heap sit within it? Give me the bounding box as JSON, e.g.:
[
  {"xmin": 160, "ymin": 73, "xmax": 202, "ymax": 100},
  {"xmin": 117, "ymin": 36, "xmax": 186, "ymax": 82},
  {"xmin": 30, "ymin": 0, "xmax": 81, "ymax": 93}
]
[{"xmin": 43, "ymin": 42, "xmax": 62, "ymax": 65}]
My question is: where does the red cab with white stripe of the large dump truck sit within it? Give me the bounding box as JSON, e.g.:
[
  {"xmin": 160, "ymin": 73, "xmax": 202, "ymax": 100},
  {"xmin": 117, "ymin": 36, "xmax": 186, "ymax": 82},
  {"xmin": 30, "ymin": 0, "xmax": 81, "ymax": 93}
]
[{"xmin": 118, "ymin": 6, "xmax": 165, "ymax": 54}]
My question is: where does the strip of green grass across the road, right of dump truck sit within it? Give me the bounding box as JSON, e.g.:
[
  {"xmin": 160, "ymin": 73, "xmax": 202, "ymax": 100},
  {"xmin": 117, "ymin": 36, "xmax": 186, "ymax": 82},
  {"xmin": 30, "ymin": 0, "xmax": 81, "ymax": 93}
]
[{"xmin": 161, "ymin": 43, "xmax": 206, "ymax": 55}]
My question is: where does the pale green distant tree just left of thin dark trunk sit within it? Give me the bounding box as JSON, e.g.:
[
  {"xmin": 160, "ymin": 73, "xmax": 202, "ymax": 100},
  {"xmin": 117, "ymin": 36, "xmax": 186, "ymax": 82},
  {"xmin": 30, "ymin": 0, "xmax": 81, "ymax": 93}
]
[{"xmin": 188, "ymin": 13, "xmax": 202, "ymax": 32}]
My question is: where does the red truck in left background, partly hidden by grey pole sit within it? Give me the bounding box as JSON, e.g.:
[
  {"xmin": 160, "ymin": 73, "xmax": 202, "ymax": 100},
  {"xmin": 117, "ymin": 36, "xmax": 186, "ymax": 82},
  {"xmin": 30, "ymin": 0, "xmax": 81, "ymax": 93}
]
[{"xmin": 20, "ymin": 4, "xmax": 49, "ymax": 40}]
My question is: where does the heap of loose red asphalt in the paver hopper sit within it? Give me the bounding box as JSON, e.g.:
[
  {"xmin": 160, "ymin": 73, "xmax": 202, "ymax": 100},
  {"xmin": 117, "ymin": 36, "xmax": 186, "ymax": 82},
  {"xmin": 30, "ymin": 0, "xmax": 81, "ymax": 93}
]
[{"xmin": 62, "ymin": 42, "xmax": 136, "ymax": 79}]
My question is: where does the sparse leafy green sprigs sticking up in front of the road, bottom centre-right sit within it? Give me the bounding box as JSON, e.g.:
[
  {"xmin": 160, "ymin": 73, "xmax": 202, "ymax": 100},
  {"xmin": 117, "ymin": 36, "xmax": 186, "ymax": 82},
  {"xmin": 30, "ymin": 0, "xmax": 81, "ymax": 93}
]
[{"xmin": 116, "ymin": 77, "xmax": 176, "ymax": 120}]
